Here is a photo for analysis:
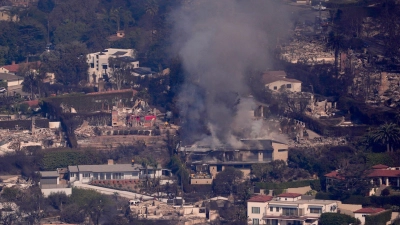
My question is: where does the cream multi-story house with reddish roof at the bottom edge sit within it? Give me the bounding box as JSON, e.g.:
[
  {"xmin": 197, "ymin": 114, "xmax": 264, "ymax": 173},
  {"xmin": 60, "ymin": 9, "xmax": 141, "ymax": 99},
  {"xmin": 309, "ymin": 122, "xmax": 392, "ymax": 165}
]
[{"xmin": 247, "ymin": 193, "xmax": 338, "ymax": 225}]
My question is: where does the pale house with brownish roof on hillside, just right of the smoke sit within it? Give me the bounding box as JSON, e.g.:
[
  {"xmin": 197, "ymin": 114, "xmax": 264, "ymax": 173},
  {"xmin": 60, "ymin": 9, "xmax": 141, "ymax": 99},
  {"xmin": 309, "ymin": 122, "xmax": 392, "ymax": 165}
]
[{"xmin": 262, "ymin": 71, "xmax": 301, "ymax": 92}]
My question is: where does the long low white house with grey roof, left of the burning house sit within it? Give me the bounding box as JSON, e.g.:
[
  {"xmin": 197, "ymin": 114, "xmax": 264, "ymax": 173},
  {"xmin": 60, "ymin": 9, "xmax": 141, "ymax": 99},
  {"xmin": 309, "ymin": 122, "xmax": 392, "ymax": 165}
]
[{"xmin": 68, "ymin": 160, "xmax": 169, "ymax": 184}]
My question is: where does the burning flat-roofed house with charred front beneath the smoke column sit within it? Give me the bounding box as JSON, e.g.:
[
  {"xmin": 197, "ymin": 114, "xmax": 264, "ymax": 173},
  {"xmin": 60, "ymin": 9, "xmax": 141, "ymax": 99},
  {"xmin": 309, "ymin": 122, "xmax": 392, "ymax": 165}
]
[{"xmin": 178, "ymin": 139, "xmax": 288, "ymax": 184}]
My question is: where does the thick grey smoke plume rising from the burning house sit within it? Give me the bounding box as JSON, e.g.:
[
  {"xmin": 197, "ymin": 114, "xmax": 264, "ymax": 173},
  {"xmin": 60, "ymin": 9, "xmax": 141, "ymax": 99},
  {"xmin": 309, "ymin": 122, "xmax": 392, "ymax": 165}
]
[{"xmin": 172, "ymin": 0, "xmax": 289, "ymax": 146}]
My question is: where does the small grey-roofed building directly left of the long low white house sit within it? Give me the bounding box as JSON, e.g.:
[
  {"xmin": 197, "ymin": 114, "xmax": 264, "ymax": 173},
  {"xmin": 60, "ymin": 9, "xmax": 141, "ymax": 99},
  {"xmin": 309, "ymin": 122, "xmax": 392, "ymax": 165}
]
[{"xmin": 39, "ymin": 170, "xmax": 72, "ymax": 197}]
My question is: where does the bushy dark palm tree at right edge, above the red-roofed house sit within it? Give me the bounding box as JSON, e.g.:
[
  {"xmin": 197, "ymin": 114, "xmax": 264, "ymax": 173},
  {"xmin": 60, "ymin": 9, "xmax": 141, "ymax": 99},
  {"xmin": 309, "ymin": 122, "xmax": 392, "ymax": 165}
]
[{"xmin": 371, "ymin": 123, "xmax": 400, "ymax": 152}]
